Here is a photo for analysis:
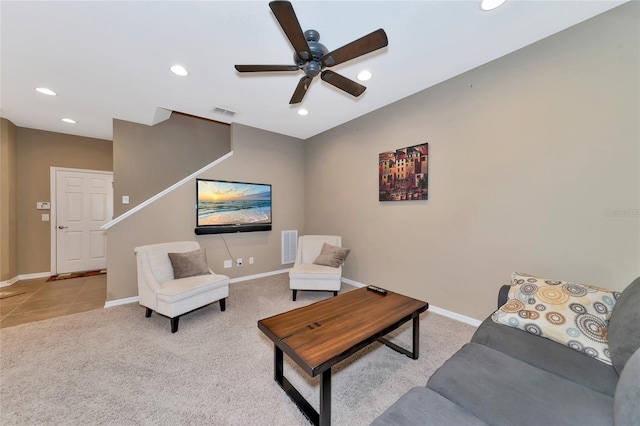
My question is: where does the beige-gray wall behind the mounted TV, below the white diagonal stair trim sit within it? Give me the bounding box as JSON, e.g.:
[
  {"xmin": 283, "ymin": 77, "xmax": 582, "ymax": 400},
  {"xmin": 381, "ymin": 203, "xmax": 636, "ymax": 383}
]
[{"xmin": 107, "ymin": 125, "xmax": 305, "ymax": 301}]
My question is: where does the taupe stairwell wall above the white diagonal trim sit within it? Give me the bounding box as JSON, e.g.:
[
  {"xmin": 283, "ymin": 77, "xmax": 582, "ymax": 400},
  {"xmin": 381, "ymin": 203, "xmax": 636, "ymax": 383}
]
[{"xmin": 113, "ymin": 112, "xmax": 231, "ymax": 217}]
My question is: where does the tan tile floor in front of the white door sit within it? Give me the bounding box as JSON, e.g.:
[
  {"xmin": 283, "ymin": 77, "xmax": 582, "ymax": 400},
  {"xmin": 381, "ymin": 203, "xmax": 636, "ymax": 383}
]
[{"xmin": 0, "ymin": 275, "xmax": 107, "ymax": 328}]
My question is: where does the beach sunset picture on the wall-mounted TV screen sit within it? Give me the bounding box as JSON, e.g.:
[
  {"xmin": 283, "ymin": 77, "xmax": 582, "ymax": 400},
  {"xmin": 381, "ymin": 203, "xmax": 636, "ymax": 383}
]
[{"xmin": 198, "ymin": 181, "xmax": 271, "ymax": 226}]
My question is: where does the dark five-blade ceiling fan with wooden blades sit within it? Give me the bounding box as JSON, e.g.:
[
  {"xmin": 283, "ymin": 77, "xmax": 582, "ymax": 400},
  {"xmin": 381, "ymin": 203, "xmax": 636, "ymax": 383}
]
[{"xmin": 235, "ymin": 1, "xmax": 388, "ymax": 104}]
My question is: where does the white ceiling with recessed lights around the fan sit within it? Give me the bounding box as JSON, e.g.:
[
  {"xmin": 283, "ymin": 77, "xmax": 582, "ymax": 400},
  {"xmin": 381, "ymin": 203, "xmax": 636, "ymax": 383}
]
[{"xmin": 0, "ymin": 0, "xmax": 626, "ymax": 139}]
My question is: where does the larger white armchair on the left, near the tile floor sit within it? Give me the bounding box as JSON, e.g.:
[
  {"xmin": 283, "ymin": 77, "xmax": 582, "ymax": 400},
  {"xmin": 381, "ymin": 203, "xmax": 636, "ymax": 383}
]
[{"xmin": 134, "ymin": 241, "xmax": 229, "ymax": 333}]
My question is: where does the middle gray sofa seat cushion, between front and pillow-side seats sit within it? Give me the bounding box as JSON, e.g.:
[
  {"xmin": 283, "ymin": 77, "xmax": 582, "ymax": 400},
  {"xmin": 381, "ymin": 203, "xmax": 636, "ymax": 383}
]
[{"xmin": 427, "ymin": 343, "xmax": 613, "ymax": 426}]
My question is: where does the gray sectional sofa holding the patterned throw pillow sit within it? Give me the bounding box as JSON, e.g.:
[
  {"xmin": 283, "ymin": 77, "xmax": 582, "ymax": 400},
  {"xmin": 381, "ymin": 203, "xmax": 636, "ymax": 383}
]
[{"xmin": 372, "ymin": 278, "xmax": 640, "ymax": 426}]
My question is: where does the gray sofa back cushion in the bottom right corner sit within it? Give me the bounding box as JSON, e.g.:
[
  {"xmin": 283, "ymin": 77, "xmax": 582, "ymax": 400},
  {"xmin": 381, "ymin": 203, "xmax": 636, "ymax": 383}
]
[{"xmin": 613, "ymin": 349, "xmax": 640, "ymax": 426}]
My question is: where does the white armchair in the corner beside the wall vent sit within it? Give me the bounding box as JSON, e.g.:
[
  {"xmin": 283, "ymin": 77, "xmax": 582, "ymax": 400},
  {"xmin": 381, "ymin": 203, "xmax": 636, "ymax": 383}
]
[{"xmin": 289, "ymin": 235, "xmax": 348, "ymax": 301}]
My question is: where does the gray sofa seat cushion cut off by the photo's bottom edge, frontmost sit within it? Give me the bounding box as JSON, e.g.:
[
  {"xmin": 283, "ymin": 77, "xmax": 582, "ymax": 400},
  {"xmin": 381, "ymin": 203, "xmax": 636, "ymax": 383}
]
[{"xmin": 371, "ymin": 386, "xmax": 486, "ymax": 426}]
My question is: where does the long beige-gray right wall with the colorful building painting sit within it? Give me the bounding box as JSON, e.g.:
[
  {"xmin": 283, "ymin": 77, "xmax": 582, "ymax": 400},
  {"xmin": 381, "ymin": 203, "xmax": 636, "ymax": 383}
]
[{"xmin": 305, "ymin": 2, "xmax": 640, "ymax": 319}]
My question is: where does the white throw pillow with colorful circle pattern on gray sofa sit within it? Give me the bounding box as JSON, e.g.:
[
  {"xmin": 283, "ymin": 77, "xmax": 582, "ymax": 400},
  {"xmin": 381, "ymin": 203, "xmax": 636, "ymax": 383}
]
[{"xmin": 491, "ymin": 272, "xmax": 620, "ymax": 364}]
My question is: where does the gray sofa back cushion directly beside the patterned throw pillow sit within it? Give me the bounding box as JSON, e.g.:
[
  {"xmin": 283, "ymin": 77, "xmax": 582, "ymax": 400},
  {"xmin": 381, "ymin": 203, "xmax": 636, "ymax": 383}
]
[{"xmin": 608, "ymin": 278, "xmax": 640, "ymax": 374}]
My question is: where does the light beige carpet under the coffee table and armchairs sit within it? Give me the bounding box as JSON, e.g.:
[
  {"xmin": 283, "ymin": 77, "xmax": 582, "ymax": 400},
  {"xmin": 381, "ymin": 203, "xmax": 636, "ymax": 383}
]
[{"xmin": 0, "ymin": 274, "xmax": 474, "ymax": 426}]
